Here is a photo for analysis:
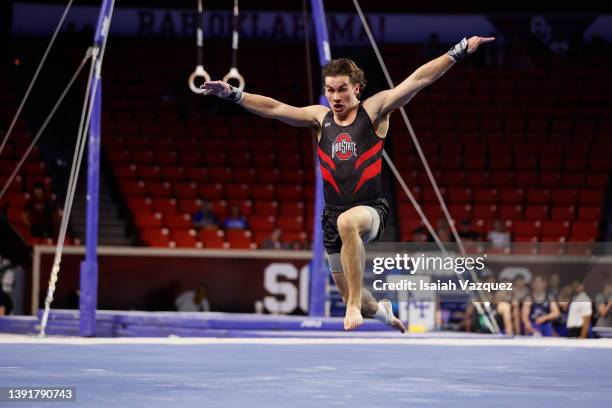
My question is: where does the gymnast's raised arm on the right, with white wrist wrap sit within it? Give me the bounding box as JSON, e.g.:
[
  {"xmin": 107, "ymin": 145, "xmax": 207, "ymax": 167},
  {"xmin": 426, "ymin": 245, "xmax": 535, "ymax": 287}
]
[{"xmin": 364, "ymin": 37, "xmax": 494, "ymax": 118}]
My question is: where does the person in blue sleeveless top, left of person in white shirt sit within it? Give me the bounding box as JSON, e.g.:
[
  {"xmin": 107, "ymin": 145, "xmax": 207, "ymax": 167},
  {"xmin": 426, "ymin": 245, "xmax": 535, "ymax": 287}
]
[{"xmin": 522, "ymin": 275, "xmax": 559, "ymax": 337}]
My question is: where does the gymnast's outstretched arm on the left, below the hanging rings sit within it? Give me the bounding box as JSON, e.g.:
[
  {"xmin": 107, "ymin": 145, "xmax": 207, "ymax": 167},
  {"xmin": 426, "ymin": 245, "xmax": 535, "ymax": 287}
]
[{"xmin": 201, "ymin": 81, "xmax": 329, "ymax": 128}]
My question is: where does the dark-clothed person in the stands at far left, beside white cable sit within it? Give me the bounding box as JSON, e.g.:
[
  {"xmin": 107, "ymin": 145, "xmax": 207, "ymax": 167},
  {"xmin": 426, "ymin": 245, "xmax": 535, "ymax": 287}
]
[{"xmin": 23, "ymin": 183, "xmax": 62, "ymax": 238}]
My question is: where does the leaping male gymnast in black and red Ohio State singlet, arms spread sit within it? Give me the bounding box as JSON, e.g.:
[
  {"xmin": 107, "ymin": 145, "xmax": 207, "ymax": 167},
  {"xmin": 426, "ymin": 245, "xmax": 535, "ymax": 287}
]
[{"xmin": 201, "ymin": 36, "xmax": 494, "ymax": 333}]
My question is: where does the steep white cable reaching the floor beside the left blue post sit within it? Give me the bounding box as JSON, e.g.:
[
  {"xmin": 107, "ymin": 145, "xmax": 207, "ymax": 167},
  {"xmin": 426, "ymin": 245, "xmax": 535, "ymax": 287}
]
[{"xmin": 39, "ymin": 0, "xmax": 115, "ymax": 337}]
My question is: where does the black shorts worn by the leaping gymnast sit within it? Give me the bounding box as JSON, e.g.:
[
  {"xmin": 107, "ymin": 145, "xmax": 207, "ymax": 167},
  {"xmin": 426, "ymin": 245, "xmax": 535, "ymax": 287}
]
[{"xmin": 321, "ymin": 198, "xmax": 389, "ymax": 254}]
